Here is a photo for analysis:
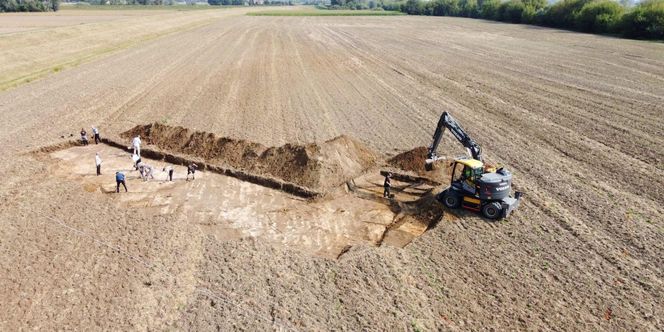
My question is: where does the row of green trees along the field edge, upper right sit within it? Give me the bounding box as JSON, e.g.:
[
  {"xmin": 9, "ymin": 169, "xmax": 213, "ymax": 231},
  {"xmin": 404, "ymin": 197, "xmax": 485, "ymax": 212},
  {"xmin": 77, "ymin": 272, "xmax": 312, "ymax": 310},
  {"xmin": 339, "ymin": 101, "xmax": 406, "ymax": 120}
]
[{"xmin": 330, "ymin": 0, "xmax": 664, "ymax": 39}]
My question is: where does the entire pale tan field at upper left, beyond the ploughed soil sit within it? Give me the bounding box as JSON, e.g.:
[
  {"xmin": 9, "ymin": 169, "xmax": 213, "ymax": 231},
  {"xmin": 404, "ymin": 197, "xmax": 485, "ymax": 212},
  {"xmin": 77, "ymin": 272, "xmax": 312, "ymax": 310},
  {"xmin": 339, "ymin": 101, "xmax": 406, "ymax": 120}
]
[{"xmin": 0, "ymin": 9, "xmax": 252, "ymax": 91}]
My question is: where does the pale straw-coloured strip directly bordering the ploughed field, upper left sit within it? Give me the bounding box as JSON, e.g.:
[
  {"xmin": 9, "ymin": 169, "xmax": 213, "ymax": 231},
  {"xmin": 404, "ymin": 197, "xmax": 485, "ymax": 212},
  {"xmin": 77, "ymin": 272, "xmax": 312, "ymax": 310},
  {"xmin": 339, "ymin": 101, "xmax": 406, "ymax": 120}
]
[{"xmin": 0, "ymin": 12, "xmax": 224, "ymax": 87}]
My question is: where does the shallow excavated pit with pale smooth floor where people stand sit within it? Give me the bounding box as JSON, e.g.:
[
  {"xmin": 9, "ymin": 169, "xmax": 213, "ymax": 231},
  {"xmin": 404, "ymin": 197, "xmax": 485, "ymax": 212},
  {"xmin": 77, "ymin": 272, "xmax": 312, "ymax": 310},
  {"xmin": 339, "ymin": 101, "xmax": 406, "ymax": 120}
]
[{"xmin": 42, "ymin": 144, "xmax": 444, "ymax": 258}]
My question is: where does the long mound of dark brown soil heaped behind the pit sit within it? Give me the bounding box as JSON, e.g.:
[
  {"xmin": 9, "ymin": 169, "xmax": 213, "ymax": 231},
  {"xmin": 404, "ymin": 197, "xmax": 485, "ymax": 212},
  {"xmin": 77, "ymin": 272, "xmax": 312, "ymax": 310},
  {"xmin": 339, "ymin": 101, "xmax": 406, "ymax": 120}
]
[{"xmin": 122, "ymin": 123, "xmax": 377, "ymax": 191}]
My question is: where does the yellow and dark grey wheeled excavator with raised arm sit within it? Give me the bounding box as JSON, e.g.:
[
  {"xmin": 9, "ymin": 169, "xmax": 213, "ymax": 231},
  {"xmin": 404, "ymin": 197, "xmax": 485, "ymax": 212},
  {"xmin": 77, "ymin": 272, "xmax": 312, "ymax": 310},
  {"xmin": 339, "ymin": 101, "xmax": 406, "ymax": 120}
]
[{"xmin": 425, "ymin": 112, "xmax": 522, "ymax": 219}]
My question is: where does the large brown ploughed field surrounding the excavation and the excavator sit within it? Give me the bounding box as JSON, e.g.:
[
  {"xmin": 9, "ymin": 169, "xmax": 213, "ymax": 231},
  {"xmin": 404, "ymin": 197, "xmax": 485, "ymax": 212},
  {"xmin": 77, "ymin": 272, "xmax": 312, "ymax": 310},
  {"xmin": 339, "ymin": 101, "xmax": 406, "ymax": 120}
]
[{"xmin": 0, "ymin": 9, "xmax": 664, "ymax": 330}]
